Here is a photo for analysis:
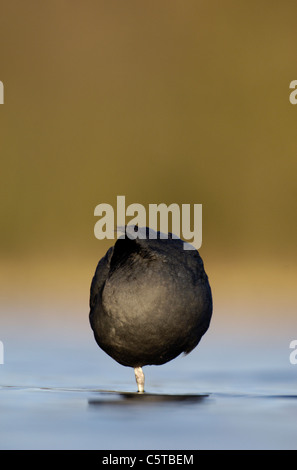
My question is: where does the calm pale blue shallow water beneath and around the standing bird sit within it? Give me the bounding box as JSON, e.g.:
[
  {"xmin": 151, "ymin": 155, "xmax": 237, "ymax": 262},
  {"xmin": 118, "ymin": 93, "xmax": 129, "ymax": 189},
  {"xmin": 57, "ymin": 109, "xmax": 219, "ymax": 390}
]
[{"xmin": 0, "ymin": 304, "xmax": 297, "ymax": 450}]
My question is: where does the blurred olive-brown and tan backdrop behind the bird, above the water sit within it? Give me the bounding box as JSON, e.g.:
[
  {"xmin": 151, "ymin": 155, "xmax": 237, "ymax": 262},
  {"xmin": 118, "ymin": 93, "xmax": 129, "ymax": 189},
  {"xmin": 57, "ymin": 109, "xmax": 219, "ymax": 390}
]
[{"xmin": 0, "ymin": 0, "xmax": 297, "ymax": 326}]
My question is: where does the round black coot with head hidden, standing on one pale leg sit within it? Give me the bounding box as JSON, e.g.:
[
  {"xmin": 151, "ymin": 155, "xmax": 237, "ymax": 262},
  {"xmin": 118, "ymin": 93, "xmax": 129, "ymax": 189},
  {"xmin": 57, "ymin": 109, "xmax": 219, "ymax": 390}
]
[{"xmin": 90, "ymin": 229, "xmax": 212, "ymax": 392}]
